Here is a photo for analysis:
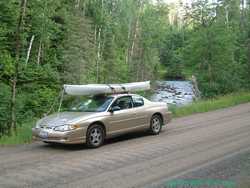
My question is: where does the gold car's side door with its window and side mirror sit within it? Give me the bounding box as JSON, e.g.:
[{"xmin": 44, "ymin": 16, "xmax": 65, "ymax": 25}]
[{"xmin": 108, "ymin": 96, "xmax": 136, "ymax": 134}]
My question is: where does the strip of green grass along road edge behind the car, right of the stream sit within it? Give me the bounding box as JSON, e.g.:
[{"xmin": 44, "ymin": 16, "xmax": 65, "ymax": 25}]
[{"xmin": 170, "ymin": 92, "xmax": 250, "ymax": 117}]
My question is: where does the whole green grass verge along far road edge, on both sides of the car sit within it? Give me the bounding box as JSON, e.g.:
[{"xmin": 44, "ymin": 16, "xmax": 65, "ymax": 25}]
[{"xmin": 0, "ymin": 92, "xmax": 250, "ymax": 145}]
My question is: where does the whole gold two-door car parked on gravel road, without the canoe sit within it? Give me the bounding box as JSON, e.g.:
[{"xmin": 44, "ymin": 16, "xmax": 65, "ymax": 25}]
[{"xmin": 32, "ymin": 94, "xmax": 171, "ymax": 148}]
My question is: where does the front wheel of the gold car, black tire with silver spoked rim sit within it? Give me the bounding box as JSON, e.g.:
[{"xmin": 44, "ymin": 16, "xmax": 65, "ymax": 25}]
[{"xmin": 86, "ymin": 124, "xmax": 105, "ymax": 148}]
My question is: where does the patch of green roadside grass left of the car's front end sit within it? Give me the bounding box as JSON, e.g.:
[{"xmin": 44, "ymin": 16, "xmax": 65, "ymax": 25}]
[{"xmin": 0, "ymin": 120, "xmax": 35, "ymax": 145}]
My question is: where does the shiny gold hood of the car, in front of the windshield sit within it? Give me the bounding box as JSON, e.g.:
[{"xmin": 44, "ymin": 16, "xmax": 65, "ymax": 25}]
[{"xmin": 38, "ymin": 112, "xmax": 99, "ymax": 127}]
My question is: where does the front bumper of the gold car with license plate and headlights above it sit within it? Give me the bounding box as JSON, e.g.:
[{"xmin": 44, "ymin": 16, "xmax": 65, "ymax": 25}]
[{"xmin": 32, "ymin": 127, "xmax": 86, "ymax": 144}]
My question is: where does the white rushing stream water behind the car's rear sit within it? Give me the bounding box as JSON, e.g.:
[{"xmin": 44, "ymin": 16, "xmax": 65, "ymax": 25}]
[{"xmin": 151, "ymin": 81, "xmax": 195, "ymax": 106}]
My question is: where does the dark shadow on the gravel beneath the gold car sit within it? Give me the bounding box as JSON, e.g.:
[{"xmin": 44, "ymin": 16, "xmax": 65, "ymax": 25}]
[{"xmin": 40, "ymin": 131, "xmax": 156, "ymax": 151}]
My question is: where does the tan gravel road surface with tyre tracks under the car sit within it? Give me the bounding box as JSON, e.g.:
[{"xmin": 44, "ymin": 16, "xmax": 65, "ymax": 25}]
[{"xmin": 0, "ymin": 103, "xmax": 250, "ymax": 188}]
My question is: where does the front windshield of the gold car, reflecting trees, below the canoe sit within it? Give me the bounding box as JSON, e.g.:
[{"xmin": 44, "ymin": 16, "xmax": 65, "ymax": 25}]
[{"xmin": 69, "ymin": 95, "xmax": 113, "ymax": 112}]
